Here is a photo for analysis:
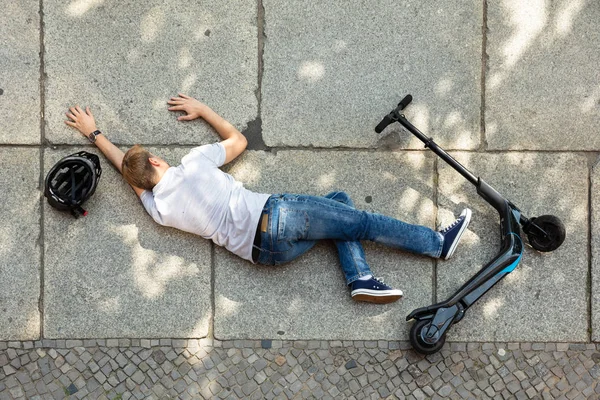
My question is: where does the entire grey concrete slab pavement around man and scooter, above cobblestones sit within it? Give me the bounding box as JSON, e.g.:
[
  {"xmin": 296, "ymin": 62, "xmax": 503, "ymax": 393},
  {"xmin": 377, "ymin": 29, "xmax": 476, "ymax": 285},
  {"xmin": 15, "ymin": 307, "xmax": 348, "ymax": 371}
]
[{"xmin": 0, "ymin": 0, "xmax": 600, "ymax": 354}]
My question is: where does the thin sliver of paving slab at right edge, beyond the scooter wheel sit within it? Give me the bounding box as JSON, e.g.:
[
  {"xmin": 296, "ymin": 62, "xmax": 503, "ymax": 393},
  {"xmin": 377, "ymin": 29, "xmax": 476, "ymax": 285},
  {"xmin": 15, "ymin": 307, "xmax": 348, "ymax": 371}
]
[{"xmin": 590, "ymin": 162, "xmax": 600, "ymax": 342}]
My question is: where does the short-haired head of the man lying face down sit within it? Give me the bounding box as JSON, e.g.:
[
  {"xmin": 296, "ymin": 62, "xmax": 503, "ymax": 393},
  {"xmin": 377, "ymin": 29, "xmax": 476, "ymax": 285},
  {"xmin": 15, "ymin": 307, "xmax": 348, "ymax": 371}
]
[{"xmin": 121, "ymin": 144, "xmax": 169, "ymax": 190}]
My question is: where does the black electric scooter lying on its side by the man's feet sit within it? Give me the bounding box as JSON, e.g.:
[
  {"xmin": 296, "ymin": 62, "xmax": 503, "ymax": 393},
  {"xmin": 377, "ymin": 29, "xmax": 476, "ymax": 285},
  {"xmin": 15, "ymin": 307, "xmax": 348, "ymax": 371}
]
[{"xmin": 375, "ymin": 95, "xmax": 566, "ymax": 354}]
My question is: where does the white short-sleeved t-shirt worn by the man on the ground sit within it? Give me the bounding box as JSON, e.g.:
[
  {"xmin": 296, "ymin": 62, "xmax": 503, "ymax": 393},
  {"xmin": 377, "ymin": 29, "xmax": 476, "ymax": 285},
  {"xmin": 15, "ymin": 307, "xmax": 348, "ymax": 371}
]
[{"xmin": 141, "ymin": 143, "xmax": 270, "ymax": 261}]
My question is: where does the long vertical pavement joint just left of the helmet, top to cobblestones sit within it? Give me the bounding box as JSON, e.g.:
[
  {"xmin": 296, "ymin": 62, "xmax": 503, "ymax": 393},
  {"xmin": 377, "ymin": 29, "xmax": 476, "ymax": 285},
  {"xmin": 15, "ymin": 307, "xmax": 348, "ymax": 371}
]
[{"xmin": 38, "ymin": 0, "xmax": 46, "ymax": 337}]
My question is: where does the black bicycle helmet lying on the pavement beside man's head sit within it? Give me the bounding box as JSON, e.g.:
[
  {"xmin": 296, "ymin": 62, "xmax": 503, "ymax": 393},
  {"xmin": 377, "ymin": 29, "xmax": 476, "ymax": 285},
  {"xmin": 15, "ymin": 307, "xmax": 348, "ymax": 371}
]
[{"xmin": 44, "ymin": 151, "xmax": 102, "ymax": 218}]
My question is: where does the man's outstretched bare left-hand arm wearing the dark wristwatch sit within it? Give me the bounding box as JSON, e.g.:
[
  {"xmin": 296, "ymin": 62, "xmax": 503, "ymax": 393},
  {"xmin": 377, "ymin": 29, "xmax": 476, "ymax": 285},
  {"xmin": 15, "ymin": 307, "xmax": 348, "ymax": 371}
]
[{"xmin": 65, "ymin": 106, "xmax": 144, "ymax": 197}]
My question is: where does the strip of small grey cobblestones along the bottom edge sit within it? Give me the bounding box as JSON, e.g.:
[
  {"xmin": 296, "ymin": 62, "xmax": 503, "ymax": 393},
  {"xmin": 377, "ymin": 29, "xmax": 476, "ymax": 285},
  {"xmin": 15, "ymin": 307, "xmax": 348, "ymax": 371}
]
[{"xmin": 0, "ymin": 339, "xmax": 600, "ymax": 400}]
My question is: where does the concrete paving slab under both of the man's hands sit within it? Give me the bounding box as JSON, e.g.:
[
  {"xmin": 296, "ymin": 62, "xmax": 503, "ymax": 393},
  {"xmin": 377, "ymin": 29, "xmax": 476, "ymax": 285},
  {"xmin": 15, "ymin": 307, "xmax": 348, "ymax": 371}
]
[{"xmin": 44, "ymin": 0, "xmax": 258, "ymax": 144}]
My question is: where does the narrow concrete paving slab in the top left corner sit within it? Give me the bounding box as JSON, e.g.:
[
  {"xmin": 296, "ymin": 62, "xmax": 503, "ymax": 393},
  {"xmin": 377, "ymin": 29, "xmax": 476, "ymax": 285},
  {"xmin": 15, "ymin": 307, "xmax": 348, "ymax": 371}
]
[{"xmin": 0, "ymin": 0, "xmax": 40, "ymax": 144}]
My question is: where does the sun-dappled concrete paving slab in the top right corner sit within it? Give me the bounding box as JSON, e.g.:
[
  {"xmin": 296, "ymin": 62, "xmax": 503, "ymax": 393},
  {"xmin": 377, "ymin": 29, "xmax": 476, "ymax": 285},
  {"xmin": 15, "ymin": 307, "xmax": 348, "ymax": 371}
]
[{"xmin": 485, "ymin": 1, "xmax": 600, "ymax": 150}]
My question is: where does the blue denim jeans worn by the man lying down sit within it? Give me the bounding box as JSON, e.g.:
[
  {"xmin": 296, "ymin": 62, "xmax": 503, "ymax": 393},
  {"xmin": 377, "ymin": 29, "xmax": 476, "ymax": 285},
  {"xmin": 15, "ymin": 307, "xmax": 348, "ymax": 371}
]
[{"xmin": 257, "ymin": 192, "xmax": 443, "ymax": 284}]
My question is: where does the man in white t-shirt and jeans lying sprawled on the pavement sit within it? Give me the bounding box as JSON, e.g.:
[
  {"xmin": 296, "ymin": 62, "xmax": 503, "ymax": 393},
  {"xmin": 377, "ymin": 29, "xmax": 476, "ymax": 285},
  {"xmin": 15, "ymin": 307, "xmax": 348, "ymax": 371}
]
[{"xmin": 65, "ymin": 94, "xmax": 471, "ymax": 303}]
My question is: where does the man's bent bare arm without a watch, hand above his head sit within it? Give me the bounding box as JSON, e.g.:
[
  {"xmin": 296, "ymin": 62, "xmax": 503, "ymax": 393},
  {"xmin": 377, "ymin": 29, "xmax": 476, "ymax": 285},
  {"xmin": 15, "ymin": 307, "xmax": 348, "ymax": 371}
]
[{"xmin": 167, "ymin": 93, "xmax": 248, "ymax": 164}]
